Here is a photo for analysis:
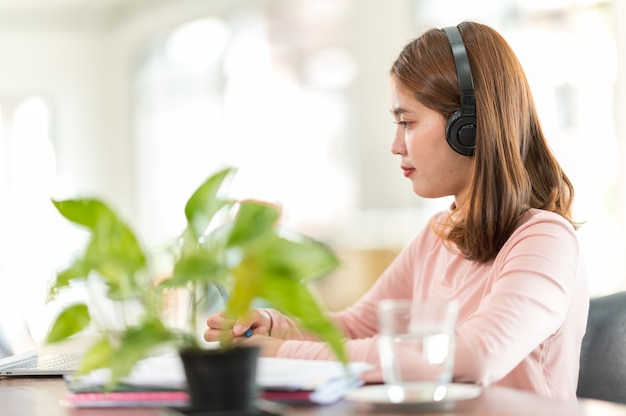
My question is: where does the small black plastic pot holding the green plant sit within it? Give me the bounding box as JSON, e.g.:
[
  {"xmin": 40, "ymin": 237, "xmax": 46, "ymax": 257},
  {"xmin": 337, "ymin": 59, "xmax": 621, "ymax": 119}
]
[{"xmin": 180, "ymin": 347, "xmax": 260, "ymax": 415}]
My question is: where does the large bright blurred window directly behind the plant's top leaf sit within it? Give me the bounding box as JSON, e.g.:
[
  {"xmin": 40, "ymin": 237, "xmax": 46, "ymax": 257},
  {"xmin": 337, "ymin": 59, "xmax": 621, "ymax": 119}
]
[{"xmin": 136, "ymin": 3, "xmax": 356, "ymax": 245}]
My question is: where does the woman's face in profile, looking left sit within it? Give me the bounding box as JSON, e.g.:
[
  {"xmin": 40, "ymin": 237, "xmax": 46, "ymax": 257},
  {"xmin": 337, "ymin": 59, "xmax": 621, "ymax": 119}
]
[{"xmin": 391, "ymin": 78, "xmax": 472, "ymax": 206}]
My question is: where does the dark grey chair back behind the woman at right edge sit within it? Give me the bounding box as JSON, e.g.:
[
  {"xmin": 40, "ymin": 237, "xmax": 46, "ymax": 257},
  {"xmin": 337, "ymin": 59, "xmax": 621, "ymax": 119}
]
[{"xmin": 576, "ymin": 292, "xmax": 626, "ymax": 403}]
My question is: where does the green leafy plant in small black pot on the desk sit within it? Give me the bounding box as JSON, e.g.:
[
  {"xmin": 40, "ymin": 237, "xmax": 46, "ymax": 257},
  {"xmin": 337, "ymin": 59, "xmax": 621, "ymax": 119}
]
[{"xmin": 47, "ymin": 167, "xmax": 346, "ymax": 411}]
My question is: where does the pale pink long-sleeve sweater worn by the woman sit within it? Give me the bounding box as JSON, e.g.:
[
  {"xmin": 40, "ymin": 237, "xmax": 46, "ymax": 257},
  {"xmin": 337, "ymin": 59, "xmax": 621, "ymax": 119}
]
[{"xmin": 269, "ymin": 209, "xmax": 589, "ymax": 400}]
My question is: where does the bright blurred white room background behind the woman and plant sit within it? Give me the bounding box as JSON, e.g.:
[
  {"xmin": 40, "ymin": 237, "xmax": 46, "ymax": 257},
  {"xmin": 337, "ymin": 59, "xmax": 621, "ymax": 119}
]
[{"xmin": 0, "ymin": 0, "xmax": 626, "ymax": 336}]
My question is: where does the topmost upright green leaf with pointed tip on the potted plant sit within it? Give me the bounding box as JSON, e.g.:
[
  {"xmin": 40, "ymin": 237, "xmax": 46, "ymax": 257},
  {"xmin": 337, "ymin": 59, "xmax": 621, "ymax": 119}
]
[{"xmin": 185, "ymin": 168, "xmax": 236, "ymax": 239}]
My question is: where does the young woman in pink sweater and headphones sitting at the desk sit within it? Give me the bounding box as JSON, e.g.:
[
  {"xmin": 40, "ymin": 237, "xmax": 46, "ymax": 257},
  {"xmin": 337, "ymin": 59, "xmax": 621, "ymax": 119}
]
[{"xmin": 204, "ymin": 22, "xmax": 589, "ymax": 399}]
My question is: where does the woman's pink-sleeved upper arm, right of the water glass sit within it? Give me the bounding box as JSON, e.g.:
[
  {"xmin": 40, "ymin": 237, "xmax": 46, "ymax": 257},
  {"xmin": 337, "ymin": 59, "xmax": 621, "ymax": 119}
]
[{"xmin": 454, "ymin": 216, "xmax": 587, "ymax": 384}]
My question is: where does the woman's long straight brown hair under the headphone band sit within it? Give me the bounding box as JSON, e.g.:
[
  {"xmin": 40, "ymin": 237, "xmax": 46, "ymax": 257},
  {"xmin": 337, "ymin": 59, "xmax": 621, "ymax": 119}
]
[{"xmin": 391, "ymin": 22, "xmax": 578, "ymax": 262}]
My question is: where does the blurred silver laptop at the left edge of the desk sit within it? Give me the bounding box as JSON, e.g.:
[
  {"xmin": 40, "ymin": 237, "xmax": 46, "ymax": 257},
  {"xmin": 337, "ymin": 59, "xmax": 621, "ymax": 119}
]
[{"xmin": 0, "ymin": 267, "xmax": 82, "ymax": 377}]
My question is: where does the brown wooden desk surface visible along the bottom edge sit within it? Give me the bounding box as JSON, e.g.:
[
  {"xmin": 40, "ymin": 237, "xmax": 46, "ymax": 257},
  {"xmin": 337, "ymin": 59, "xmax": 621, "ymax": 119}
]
[{"xmin": 0, "ymin": 378, "xmax": 626, "ymax": 416}]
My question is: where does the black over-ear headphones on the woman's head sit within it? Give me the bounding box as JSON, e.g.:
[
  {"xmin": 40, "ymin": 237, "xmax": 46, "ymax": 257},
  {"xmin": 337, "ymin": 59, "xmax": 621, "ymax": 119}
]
[{"xmin": 443, "ymin": 26, "xmax": 476, "ymax": 156}]
